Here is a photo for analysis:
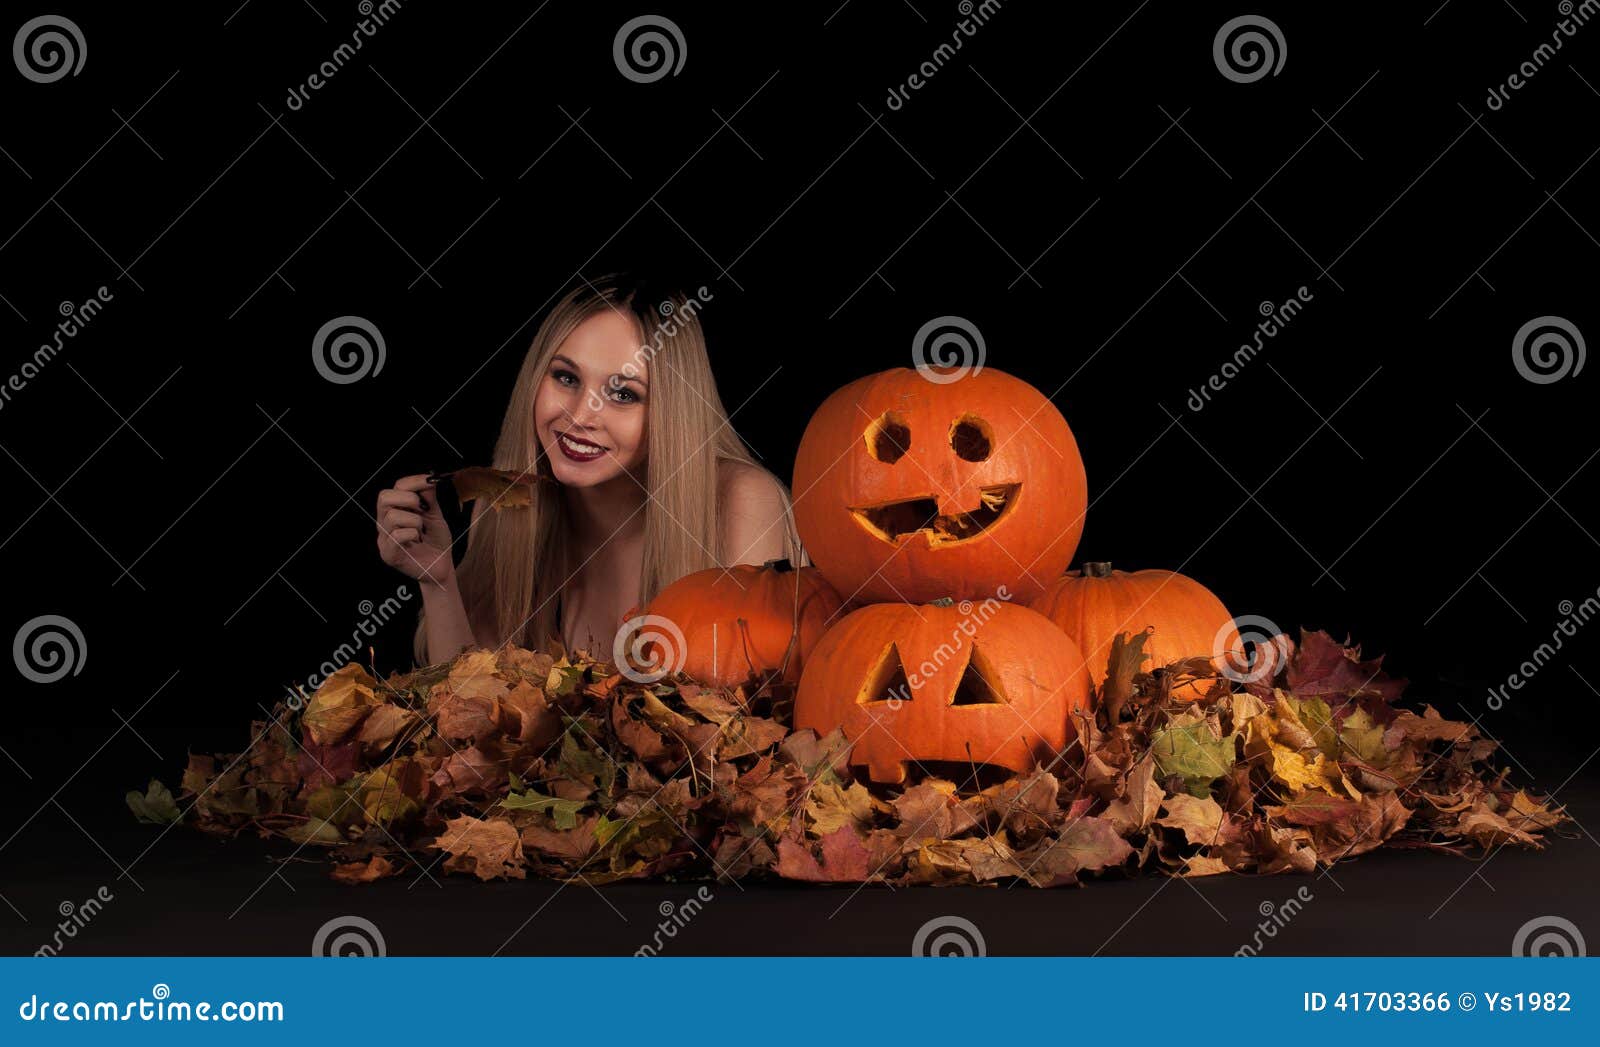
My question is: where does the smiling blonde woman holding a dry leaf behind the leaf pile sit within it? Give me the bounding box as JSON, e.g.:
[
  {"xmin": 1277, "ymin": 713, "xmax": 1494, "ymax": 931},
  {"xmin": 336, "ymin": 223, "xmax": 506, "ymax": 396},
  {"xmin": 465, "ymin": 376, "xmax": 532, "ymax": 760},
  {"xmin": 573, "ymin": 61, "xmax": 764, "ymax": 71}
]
[{"xmin": 376, "ymin": 277, "xmax": 803, "ymax": 663}]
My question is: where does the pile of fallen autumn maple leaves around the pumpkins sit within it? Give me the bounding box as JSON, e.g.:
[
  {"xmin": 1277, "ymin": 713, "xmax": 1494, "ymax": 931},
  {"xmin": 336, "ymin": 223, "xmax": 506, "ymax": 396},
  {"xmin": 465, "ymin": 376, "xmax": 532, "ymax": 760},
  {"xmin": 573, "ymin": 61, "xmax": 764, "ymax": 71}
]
[{"xmin": 128, "ymin": 632, "xmax": 1570, "ymax": 887}]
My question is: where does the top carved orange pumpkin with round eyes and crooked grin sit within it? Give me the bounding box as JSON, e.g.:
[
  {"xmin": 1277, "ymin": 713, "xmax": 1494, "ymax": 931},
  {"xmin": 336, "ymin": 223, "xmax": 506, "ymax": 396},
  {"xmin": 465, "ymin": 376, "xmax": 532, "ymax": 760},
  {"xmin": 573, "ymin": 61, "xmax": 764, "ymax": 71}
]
[{"xmin": 794, "ymin": 367, "xmax": 1088, "ymax": 604}]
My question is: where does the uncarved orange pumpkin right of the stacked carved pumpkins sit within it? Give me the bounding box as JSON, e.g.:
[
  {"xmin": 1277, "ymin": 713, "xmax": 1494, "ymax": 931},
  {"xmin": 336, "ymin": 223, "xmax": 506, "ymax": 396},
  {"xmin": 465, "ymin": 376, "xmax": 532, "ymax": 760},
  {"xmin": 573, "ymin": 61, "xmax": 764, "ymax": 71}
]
[{"xmin": 1030, "ymin": 560, "xmax": 1240, "ymax": 701}]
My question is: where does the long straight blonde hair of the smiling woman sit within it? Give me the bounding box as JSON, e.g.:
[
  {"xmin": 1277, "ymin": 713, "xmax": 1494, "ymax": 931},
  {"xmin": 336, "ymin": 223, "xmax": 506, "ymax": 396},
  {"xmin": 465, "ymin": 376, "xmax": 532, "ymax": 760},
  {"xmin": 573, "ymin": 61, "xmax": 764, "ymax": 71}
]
[{"xmin": 414, "ymin": 275, "xmax": 806, "ymax": 663}]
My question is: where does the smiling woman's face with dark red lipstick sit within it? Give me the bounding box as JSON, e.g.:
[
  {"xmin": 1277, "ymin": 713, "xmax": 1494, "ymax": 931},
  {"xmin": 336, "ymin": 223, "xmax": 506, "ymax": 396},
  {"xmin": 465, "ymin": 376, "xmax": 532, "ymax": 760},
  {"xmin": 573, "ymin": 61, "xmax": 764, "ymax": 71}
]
[{"xmin": 533, "ymin": 309, "xmax": 650, "ymax": 487}]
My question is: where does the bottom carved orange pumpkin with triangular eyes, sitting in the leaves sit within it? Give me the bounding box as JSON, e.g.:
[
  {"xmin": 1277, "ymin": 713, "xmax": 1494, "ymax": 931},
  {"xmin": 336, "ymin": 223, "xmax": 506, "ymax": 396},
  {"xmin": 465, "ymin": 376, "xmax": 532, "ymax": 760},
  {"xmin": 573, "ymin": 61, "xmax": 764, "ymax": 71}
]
[{"xmin": 795, "ymin": 597, "xmax": 1090, "ymax": 783}]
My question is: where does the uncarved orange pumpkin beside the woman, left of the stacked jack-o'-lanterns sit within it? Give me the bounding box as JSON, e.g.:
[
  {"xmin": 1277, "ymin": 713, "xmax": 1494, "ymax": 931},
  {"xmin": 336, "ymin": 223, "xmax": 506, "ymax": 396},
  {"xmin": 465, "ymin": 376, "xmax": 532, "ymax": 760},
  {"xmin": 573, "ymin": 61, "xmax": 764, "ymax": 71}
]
[{"xmin": 630, "ymin": 560, "xmax": 840, "ymax": 687}]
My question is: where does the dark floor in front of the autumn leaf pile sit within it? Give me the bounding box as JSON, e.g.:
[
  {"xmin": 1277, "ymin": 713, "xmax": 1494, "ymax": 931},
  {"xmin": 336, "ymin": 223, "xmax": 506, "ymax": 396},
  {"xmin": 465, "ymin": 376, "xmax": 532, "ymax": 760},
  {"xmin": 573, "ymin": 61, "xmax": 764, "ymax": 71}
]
[{"xmin": 0, "ymin": 739, "xmax": 1600, "ymax": 956}]
